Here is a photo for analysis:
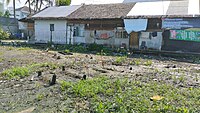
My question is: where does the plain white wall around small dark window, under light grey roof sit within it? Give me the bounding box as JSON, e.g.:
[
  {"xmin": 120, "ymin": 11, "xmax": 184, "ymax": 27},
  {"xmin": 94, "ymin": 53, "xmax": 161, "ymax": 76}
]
[{"xmin": 35, "ymin": 20, "xmax": 67, "ymax": 44}]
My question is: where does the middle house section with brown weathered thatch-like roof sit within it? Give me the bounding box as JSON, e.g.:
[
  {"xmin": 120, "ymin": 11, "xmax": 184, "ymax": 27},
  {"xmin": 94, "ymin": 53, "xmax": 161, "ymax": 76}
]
[{"xmin": 67, "ymin": 3, "xmax": 134, "ymax": 47}]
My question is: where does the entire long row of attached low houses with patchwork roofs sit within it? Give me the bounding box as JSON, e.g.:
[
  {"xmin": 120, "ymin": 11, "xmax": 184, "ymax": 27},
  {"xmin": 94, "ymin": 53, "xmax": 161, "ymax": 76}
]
[{"xmin": 32, "ymin": 0, "xmax": 200, "ymax": 52}]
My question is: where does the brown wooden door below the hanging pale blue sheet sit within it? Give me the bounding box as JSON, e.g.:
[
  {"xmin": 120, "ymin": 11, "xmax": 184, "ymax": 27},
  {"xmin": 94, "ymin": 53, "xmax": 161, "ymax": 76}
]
[{"xmin": 129, "ymin": 32, "xmax": 139, "ymax": 49}]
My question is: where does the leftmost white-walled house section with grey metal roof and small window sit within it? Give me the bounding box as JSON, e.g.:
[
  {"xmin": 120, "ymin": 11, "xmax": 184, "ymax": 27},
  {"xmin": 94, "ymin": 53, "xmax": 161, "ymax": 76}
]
[{"xmin": 32, "ymin": 5, "xmax": 81, "ymax": 44}]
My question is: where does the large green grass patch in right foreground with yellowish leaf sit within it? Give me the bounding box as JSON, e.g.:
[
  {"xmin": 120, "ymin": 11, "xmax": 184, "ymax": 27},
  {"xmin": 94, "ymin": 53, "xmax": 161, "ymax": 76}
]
[{"xmin": 61, "ymin": 77, "xmax": 200, "ymax": 113}]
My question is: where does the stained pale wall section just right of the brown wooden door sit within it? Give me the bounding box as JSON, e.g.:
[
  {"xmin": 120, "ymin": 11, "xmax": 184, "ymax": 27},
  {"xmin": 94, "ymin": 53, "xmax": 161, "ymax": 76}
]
[{"xmin": 139, "ymin": 32, "xmax": 162, "ymax": 50}]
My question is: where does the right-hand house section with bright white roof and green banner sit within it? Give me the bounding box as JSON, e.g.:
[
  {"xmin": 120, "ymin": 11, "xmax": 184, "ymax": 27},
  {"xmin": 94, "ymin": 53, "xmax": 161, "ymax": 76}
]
[{"xmin": 124, "ymin": 0, "xmax": 200, "ymax": 52}]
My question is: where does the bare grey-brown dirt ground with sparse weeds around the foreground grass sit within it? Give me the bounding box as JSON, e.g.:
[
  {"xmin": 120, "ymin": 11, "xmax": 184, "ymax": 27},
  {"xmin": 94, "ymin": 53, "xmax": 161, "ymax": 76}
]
[{"xmin": 0, "ymin": 46, "xmax": 200, "ymax": 113}]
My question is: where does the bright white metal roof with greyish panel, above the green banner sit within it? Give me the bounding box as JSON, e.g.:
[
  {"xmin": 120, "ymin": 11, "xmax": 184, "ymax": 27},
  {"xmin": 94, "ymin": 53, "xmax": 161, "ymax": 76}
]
[{"xmin": 127, "ymin": 0, "xmax": 200, "ymax": 17}]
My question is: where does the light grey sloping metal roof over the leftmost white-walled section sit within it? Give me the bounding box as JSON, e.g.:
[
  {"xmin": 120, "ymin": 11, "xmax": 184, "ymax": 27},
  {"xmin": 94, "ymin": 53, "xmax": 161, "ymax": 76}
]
[{"xmin": 32, "ymin": 5, "xmax": 81, "ymax": 19}]
